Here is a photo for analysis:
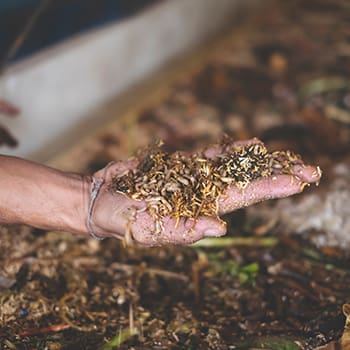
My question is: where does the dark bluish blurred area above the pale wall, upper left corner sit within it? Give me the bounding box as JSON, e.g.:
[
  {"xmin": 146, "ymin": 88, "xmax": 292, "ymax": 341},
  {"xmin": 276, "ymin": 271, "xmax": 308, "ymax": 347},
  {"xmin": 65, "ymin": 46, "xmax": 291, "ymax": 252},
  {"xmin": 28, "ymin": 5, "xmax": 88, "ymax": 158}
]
[{"xmin": 0, "ymin": 0, "xmax": 157, "ymax": 62}]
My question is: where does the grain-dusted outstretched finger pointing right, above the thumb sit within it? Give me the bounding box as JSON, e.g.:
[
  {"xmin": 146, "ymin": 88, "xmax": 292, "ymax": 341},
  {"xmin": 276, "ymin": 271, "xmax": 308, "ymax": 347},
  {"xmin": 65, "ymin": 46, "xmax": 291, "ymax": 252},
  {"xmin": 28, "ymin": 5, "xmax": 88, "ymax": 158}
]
[{"xmin": 219, "ymin": 165, "xmax": 321, "ymax": 215}]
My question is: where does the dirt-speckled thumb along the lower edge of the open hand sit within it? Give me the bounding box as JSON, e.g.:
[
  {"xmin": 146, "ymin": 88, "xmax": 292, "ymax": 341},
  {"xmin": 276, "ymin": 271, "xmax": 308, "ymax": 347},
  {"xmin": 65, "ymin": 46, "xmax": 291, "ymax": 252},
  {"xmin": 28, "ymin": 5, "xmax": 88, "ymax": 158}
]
[{"xmin": 131, "ymin": 212, "xmax": 226, "ymax": 246}]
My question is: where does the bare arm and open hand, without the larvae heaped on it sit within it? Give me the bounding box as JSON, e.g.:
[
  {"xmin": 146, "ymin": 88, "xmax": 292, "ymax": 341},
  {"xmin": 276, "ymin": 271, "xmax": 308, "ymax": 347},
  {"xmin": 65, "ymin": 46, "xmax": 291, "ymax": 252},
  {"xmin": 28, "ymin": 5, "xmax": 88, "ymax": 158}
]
[{"xmin": 0, "ymin": 141, "xmax": 321, "ymax": 245}]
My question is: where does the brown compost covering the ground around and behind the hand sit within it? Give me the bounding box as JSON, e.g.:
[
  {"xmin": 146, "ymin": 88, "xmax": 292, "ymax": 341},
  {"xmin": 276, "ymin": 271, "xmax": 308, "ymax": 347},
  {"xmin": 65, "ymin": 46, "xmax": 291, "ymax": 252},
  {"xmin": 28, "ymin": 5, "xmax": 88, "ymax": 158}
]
[{"xmin": 0, "ymin": 0, "xmax": 350, "ymax": 349}]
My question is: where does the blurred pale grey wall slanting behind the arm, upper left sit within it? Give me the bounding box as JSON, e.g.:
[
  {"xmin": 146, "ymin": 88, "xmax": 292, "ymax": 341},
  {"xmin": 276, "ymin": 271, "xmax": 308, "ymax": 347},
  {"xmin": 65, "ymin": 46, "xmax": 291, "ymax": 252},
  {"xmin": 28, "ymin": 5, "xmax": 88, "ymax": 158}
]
[{"xmin": 0, "ymin": 0, "xmax": 258, "ymax": 160}]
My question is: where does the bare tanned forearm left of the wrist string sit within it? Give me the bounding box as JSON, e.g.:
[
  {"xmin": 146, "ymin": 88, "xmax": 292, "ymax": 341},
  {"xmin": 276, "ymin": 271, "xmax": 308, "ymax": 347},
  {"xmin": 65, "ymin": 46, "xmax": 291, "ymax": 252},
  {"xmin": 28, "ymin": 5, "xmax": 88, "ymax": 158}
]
[{"xmin": 0, "ymin": 156, "xmax": 89, "ymax": 233}]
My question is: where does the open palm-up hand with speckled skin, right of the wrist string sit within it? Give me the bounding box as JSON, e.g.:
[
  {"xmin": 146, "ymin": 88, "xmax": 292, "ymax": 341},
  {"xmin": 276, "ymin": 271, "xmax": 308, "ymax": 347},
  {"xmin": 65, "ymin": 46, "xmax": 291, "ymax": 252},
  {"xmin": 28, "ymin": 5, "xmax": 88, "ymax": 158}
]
[{"xmin": 87, "ymin": 139, "xmax": 321, "ymax": 245}]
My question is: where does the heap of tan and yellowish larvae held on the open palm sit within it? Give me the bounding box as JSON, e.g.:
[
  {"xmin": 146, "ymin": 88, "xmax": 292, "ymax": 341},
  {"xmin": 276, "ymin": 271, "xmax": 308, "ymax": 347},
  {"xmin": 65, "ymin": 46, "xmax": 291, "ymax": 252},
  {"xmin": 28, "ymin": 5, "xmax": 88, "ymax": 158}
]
[{"xmin": 110, "ymin": 140, "xmax": 318, "ymax": 234}]
